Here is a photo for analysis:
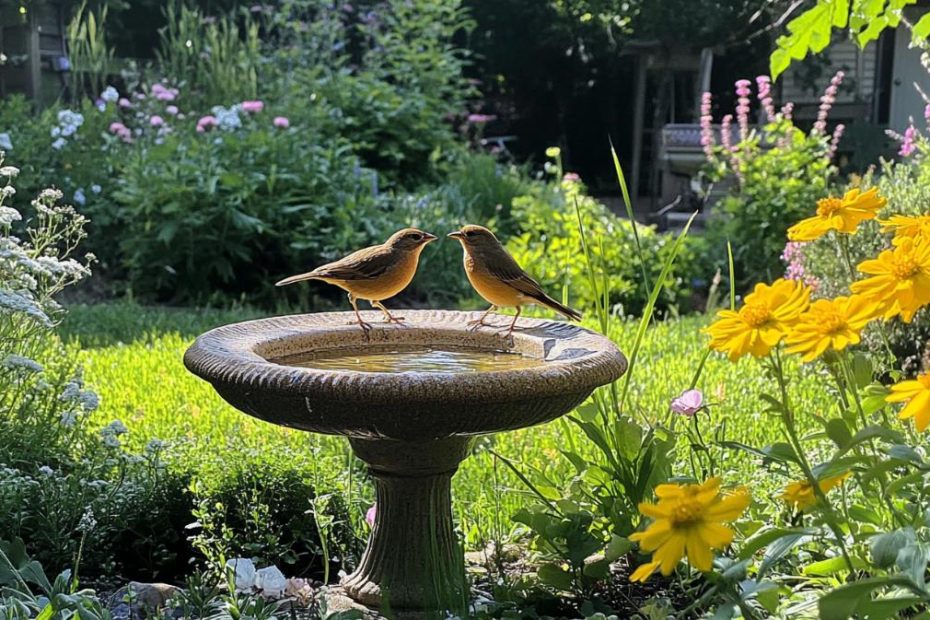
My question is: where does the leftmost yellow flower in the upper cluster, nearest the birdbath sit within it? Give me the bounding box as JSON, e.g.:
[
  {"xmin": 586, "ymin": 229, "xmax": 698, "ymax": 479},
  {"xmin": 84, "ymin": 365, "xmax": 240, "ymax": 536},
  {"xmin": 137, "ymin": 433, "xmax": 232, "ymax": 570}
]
[{"xmin": 705, "ymin": 279, "xmax": 810, "ymax": 362}]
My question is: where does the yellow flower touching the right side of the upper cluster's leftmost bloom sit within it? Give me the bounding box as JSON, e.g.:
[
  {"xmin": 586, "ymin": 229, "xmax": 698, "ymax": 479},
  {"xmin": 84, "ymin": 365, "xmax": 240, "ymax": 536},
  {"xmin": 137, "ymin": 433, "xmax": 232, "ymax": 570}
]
[{"xmin": 785, "ymin": 295, "xmax": 879, "ymax": 362}]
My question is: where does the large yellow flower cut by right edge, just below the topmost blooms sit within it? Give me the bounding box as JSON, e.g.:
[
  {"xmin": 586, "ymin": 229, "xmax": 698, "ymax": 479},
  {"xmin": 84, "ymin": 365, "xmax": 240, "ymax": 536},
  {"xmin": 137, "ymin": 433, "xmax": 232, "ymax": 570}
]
[{"xmin": 850, "ymin": 237, "xmax": 930, "ymax": 323}]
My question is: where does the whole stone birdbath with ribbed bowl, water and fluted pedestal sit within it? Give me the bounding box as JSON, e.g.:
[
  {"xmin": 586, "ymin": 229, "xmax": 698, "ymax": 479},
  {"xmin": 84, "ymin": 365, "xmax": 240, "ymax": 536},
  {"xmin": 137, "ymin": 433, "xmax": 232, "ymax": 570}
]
[{"xmin": 184, "ymin": 310, "xmax": 627, "ymax": 615}]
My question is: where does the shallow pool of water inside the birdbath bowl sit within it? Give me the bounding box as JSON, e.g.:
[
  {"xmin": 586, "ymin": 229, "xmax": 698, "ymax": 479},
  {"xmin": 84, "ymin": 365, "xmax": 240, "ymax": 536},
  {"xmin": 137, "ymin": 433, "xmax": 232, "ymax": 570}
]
[{"xmin": 270, "ymin": 346, "xmax": 546, "ymax": 374}]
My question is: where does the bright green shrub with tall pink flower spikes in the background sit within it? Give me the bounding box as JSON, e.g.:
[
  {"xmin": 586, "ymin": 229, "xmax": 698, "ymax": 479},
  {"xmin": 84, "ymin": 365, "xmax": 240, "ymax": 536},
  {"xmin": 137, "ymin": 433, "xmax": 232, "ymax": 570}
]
[{"xmin": 702, "ymin": 74, "xmax": 842, "ymax": 290}]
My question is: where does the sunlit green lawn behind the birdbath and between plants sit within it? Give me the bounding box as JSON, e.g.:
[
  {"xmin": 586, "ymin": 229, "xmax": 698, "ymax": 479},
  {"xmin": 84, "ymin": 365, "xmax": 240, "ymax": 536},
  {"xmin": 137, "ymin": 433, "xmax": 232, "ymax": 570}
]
[{"xmin": 62, "ymin": 304, "xmax": 832, "ymax": 547}]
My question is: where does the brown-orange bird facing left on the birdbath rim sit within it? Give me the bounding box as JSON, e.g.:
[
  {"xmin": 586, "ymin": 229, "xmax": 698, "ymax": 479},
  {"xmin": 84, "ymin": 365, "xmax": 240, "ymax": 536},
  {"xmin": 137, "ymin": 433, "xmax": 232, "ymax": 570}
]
[{"xmin": 448, "ymin": 224, "xmax": 581, "ymax": 336}]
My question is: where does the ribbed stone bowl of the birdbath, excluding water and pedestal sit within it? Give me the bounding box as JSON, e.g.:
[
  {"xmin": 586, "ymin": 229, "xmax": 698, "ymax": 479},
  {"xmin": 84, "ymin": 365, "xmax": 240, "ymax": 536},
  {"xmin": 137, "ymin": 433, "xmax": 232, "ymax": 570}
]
[{"xmin": 184, "ymin": 310, "xmax": 627, "ymax": 440}]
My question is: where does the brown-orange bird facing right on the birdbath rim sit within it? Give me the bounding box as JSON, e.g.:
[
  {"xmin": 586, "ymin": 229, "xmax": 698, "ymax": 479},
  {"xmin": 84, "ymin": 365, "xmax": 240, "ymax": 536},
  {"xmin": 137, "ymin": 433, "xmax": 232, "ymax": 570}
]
[{"xmin": 275, "ymin": 228, "xmax": 436, "ymax": 338}]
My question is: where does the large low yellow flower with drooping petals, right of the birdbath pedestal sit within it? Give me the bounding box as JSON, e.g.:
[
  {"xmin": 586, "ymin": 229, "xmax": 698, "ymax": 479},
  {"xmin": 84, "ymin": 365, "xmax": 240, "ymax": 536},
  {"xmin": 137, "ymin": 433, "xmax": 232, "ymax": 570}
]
[{"xmin": 630, "ymin": 478, "xmax": 749, "ymax": 581}]
